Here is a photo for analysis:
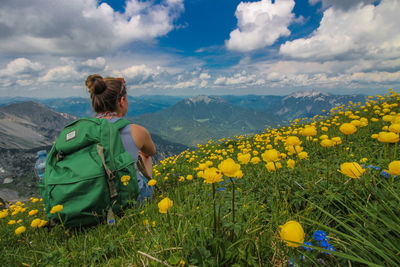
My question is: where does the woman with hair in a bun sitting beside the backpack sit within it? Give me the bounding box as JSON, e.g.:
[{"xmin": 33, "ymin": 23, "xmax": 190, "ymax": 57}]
[{"xmin": 86, "ymin": 74, "xmax": 156, "ymax": 201}]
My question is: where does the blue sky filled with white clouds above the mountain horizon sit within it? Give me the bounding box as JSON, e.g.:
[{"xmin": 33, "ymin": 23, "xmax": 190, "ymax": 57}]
[{"xmin": 0, "ymin": 0, "xmax": 400, "ymax": 97}]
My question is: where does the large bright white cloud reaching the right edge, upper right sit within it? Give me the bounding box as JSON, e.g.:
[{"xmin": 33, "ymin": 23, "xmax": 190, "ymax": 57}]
[{"xmin": 280, "ymin": 0, "xmax": 400, "ymax": 60}]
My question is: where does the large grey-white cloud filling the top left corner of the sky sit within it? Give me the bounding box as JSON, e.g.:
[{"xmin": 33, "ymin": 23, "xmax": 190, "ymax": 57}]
[{"xmin": 0, "ymin": 0, "xmax": 183, "ymax": 55}]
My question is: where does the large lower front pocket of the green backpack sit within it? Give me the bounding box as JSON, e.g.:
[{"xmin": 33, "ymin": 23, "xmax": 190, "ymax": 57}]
[{"xmin": 45, "ymin": 145, "xmax": 110, "ymax": 226}]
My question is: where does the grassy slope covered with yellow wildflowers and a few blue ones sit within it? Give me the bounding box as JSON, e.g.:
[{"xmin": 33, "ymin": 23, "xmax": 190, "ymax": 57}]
[{"xmin": 0, "ymin": 90, "xmax": 400, "ymax": 266}]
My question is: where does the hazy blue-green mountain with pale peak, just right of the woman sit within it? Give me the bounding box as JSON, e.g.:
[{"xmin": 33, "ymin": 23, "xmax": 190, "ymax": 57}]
[{"xmin": 127, "ymin": 95, "xmax": 278, "ymax": 147}]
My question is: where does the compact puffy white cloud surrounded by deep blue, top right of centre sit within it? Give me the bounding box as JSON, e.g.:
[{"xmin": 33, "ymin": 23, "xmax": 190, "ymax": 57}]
[{"xmin": 225, "ymin": 0, "xmax": 295, "ymax": 52}]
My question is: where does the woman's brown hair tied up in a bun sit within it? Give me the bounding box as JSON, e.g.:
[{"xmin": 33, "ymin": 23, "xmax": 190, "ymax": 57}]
[{"xmin": 85, "ymin": 74, "xmax": 126, "ymax": 113}]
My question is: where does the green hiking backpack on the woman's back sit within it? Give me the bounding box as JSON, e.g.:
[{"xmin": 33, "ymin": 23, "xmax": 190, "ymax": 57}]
[{"xmin": 39, "ymin": 117, "xmax": 139, "ymax": 227}]
